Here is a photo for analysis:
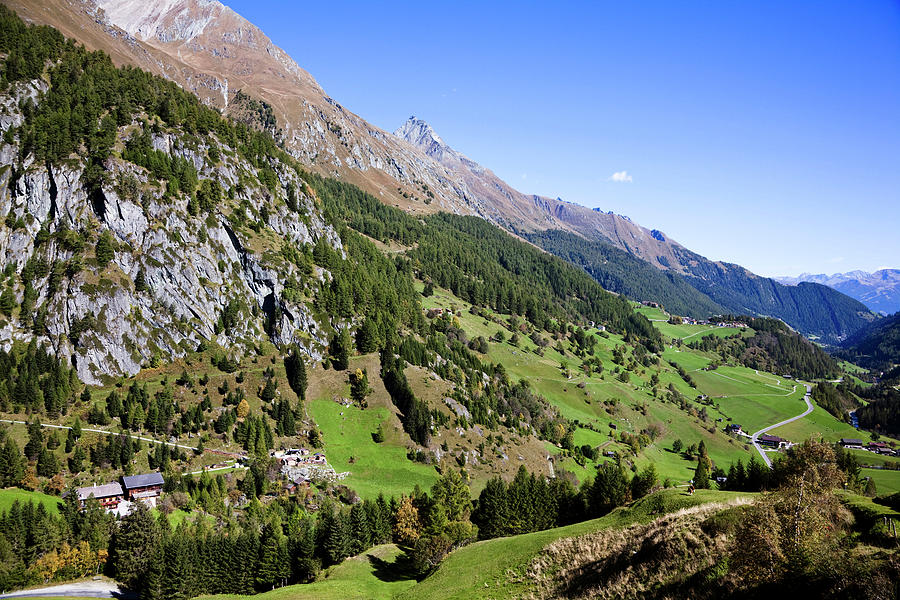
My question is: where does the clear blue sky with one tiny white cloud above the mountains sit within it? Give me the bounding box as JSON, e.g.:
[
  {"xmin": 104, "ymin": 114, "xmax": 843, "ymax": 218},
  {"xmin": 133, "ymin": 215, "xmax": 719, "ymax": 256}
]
[{"xmin": 226, "ymin": 0, "xmax": 900, "ymax": 275}]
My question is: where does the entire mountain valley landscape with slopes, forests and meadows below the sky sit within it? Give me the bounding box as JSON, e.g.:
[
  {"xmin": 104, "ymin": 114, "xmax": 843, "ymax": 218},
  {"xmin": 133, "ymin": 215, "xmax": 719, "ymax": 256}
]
[{"xmin": 0, "ymin": 0, "xmax": 900, "ymax": 600}]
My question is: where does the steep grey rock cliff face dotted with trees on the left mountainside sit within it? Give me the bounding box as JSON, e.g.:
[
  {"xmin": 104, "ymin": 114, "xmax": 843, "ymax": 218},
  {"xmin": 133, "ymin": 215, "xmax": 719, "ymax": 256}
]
[{"xmin": 0, "ymin": 83, "xmax": 341, "ymax": 383}]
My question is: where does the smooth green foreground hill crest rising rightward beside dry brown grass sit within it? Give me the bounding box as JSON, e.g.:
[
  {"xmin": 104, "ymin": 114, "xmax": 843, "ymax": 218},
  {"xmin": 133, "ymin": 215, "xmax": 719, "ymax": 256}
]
[{"xmin": 399, "ymin": 490, "xmax": 747, "ymax": 600}]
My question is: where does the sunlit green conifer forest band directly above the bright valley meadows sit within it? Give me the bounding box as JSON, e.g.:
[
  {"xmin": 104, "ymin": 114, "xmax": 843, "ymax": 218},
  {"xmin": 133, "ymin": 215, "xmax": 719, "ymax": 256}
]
[{"xmin": 310, "ymin": 177, "xmax": 660, "ymax": 343}]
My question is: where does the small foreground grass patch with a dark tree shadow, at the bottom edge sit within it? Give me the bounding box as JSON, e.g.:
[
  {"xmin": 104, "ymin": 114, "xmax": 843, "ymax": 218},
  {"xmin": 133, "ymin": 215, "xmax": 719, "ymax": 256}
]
[{"xmin": 203, "ymin": 544, "xmax": 416, "ymax": 600}]
